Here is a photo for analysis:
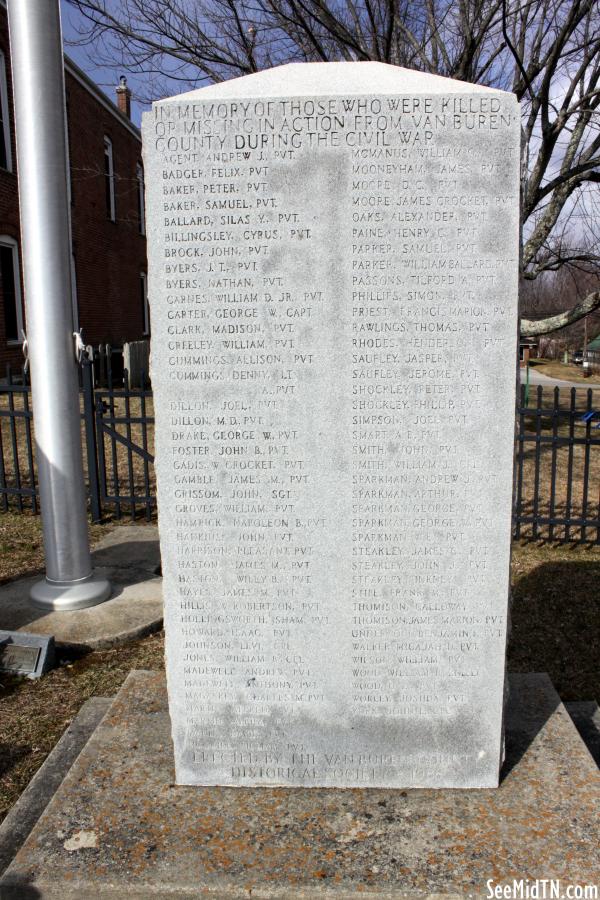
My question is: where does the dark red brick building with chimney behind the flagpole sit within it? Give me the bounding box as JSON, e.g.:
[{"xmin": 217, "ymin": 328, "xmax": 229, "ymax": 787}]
[{"xmin": 0, "ymin": 6, "xmax": 150, "ymax": 376}]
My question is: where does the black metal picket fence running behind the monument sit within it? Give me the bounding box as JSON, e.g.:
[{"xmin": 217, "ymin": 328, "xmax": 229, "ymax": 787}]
[{"xmin": 0, "ymin": 360, "xmax": 600, "ymax": 544}]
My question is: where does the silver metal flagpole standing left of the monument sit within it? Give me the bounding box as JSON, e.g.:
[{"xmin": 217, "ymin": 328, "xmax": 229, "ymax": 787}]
[{"xmin": 8, "ymin": 0, "xmax": 111, "ymax": 610}]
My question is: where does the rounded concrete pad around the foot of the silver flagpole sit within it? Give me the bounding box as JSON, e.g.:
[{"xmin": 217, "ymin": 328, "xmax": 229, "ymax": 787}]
[{"xmin": 0, "ymin": 525, "xmax": 163, "ymax": 650}]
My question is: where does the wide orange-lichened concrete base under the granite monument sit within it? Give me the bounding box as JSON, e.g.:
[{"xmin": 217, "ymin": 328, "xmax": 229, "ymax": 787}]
[{"xmin": 0, "ymin": 672, "xmax": 600, "ymax": 900}]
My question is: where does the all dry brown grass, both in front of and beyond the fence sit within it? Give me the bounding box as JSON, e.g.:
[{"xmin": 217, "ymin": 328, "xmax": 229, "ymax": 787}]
[{"xmin": 0, "ymin": 391, "xmax": 600, "ymax": 819}]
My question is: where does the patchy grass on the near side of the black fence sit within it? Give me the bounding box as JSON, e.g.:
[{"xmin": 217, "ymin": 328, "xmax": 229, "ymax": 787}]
[{"xmin": 0, "ymin": 515, "xmax": 600, "ymax": 821}]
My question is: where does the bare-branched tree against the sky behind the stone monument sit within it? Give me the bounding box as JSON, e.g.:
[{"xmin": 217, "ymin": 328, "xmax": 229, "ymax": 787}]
[{"xmin": 68, "ymin": 0, "xmax": 600, "ymax": 336}]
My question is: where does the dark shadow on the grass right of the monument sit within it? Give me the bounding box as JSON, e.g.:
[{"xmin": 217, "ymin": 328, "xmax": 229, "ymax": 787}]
[{"xmin": 508, "ymin": 560, "xmax": 600, "ymax": 700}]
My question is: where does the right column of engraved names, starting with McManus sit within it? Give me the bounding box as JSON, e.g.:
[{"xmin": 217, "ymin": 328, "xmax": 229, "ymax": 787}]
[{"xmin": 352, "ymin": 99, "xmax": 502, "ymax": 717}]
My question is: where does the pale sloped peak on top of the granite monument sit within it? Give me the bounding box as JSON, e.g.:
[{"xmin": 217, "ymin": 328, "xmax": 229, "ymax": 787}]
[{"xmin": 158, "ymin": 62, "xmax": 506, "ymax": 103}]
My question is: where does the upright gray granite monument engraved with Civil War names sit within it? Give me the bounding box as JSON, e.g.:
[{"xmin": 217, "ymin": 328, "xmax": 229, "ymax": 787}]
[{"xmin": 143, "ymin": 63, "xmax": 520, "ymax": 787}]
